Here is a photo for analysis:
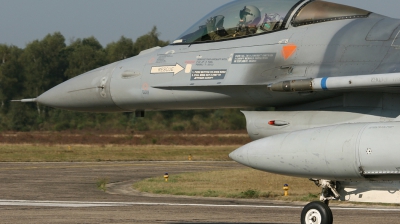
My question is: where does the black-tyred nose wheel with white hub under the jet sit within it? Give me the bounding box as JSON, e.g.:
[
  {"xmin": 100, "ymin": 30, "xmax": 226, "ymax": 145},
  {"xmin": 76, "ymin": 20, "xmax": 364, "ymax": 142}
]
[{"xmin": 301, "ymin": 201, "xmax": 333, "ymax": 224}]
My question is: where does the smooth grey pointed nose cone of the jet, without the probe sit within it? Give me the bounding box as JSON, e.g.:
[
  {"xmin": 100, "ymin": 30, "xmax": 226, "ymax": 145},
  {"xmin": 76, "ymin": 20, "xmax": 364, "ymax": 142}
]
[{"xmin": 37, "ymin": 63, "xmax": 125, "ymax": 112}]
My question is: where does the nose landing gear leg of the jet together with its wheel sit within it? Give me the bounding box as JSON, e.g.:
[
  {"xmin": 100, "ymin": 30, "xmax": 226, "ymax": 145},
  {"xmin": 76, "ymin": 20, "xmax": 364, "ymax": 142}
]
[{"xmin": 301, "ymin": 179, "xmax": 340, "ymax": 224}]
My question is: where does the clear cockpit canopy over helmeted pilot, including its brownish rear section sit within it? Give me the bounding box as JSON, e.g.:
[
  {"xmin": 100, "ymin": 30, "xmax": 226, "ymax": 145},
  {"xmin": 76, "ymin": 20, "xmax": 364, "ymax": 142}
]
[{"xmin": 173, "ymin": 0, "xmax": 370, "ymax": 44}]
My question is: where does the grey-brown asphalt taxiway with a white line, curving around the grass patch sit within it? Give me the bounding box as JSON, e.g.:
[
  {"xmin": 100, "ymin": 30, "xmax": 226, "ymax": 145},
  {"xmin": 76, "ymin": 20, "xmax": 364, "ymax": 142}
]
[{"xmin": 0, "ymin": 162, "xmax": 400, "ymax": 224}]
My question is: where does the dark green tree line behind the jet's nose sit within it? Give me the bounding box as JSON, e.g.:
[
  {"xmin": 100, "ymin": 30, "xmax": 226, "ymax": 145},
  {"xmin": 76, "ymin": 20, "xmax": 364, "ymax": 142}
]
[{"xmin": 0, "ymin": 27, "xmax": 245, "ymax": 131}]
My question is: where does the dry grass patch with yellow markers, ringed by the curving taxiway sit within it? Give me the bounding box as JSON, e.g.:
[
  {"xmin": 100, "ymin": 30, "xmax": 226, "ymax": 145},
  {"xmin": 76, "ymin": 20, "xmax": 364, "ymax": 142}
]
[{"xmin": 133, "ymin": 168, "xmax": 320, "ymax": 201}]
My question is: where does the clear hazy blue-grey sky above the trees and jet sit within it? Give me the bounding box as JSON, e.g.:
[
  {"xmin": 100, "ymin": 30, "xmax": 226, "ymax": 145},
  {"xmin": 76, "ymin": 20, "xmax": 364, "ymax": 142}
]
[{"xmin": 0, "ymin": 0, "xmax": 400, "ymax": 48}]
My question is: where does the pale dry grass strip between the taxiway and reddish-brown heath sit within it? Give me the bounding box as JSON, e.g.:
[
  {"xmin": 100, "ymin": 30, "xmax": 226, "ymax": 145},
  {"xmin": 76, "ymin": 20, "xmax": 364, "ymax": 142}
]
[{"xmin": 0, "ymin": 144, "xmax": 239, "ymax": 162}]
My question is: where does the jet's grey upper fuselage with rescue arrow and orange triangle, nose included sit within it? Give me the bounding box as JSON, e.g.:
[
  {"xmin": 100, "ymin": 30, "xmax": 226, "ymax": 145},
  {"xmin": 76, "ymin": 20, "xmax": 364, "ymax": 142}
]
[{"xmin": 37, "ymin": 1, "xmax": 400, "ymax": 112}]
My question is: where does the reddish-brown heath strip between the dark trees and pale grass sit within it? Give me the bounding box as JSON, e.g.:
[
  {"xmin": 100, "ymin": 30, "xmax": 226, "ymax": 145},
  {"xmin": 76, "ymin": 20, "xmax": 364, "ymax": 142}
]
[{"xmin": 0, "ymin": 131, "xmax": 251, "ymax": 146}]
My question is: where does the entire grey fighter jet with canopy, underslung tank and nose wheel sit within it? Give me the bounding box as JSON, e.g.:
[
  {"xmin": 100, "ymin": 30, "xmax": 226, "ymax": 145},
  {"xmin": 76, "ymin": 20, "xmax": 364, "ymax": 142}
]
[{"xmin": 15, "ymin": 0, "xmax": 400, "ymax": 223}]
